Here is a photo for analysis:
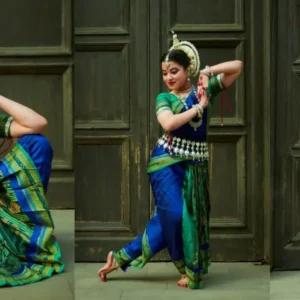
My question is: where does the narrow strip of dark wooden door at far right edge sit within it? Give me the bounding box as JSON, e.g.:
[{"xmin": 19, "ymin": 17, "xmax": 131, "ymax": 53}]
[{"xmin": 272, "ymin": 0, "xmax": 300, "ymax": 270}]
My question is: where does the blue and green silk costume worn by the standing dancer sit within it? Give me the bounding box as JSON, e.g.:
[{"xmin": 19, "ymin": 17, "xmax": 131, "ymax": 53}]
[{"xmin": 114, "ymin": 75, "xmax": 223, "ymax": 289}]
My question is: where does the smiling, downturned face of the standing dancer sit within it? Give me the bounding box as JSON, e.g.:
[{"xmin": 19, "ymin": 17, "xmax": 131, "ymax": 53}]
[{"xmin": 161, "ymin": 61, "xmax": 188, "ymax": 91}]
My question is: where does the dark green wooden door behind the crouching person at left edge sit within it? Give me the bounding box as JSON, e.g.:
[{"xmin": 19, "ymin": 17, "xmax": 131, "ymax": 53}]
[{"xmin": 0, "ymin": 0, "xmax": 74, "ymax": 208}]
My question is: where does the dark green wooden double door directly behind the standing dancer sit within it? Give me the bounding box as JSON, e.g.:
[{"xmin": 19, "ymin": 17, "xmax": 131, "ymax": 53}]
[{"xmin": 74, "ymin": 0, "xmax": 265, "ymax": 261}]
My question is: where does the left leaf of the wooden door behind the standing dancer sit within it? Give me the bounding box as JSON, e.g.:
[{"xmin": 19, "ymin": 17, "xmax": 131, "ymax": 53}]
[{"xmin": 74, "ymin": 0, "xmax": 149, "ymax": 261}]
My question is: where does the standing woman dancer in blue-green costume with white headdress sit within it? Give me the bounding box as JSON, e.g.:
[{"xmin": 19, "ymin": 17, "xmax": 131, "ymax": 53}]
[{"xmin": 98, "ymin": 31, "xmax": 242, "ymax": 289}]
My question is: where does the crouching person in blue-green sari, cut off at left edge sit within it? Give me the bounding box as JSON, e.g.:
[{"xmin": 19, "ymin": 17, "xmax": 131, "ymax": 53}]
[{"xmin": 0, "ymin": 96, "xmax": 65, "ymax": 286}]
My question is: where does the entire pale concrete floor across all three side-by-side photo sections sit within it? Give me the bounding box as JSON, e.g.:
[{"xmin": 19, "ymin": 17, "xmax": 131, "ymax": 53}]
[{"xmin": 0, "ymin": 210, "xmax": 300, "ymax": 300}]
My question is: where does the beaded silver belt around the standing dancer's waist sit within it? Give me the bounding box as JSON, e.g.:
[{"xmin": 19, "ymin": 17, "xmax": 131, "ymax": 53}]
[{"xmin": 157, "ymin": 134, "xmax": 209, "ymax": 160}]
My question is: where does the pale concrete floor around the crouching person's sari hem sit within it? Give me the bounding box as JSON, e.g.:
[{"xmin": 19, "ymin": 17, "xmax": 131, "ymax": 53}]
[{"xmin": 0, "ymin": 210, "xmax": 74, "ymax": 300}]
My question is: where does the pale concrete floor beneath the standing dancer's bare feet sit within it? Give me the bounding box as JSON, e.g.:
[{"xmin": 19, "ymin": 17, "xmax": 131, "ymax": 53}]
[{"xmin": 75, "ymin": 263, "xmax": 272, "ymax": 300}]
